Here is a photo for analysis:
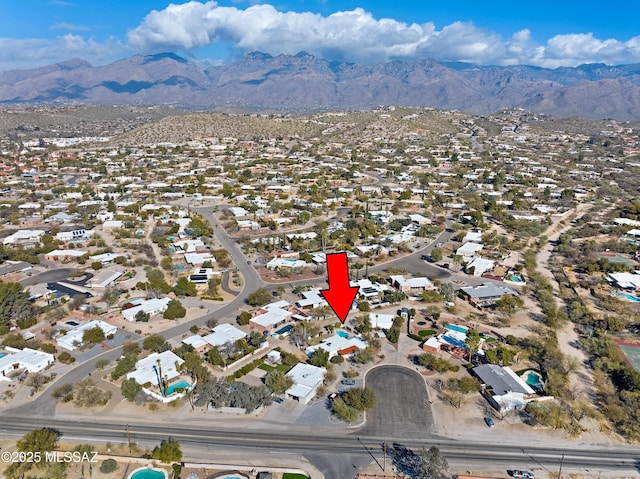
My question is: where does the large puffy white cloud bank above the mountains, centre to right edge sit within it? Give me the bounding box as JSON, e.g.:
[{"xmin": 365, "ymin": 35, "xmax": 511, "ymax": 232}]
[{"xmin": 128, "ymin": 1, "xmax": 640, "ymax": 67}]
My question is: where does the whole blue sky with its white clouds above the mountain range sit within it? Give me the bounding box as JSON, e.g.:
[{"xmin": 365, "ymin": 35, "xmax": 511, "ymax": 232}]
[{"xmin": 0, "ymin": 0, "xmax": 640, "ymax": 71}]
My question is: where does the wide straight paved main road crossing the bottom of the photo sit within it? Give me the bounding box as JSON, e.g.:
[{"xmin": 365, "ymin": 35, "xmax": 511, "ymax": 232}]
[{"xmin": 0, "ymin": 416, "xmax": 640, "ymax": 479}]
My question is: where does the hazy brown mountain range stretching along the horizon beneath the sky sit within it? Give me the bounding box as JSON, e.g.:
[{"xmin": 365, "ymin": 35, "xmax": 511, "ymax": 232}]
[{"xmin": 0, "ymin": 52, "xmax": 640, "ymax": 120}]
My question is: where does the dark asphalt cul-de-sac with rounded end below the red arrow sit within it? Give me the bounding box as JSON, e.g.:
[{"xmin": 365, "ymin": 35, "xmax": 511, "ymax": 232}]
[{"xmin": 356, "ymin": 366, "xmax": 434, "ymax": 438}]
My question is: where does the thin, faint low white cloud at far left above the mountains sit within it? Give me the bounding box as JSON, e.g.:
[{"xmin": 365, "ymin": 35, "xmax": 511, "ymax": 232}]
[{"xmin": 0, "ymin": 33, "xmax": 125, "ymax": 71}]
